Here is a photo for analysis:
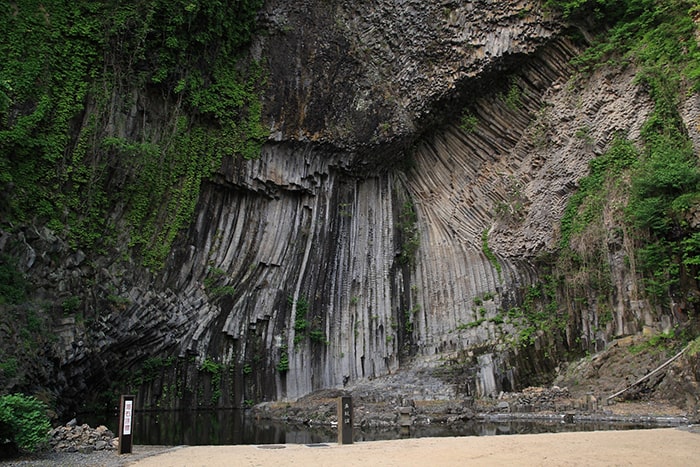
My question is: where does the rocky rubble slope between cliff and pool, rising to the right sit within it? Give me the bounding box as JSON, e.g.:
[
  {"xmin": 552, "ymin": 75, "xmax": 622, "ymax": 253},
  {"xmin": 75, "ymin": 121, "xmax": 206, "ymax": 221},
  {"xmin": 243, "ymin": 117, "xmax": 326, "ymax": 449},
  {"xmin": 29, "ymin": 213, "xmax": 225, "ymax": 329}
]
[{"xmin": 252, "ymin": 336, "xmax": 700, "ymax": 429}]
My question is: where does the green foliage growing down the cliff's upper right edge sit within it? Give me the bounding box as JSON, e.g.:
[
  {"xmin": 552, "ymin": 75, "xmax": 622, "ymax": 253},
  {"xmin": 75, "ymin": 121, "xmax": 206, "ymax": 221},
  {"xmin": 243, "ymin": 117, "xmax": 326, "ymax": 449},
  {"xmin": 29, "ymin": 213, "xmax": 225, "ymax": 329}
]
[{"xmin": 548, "ymin": 0, "xmax": 700, "ymax": 303}]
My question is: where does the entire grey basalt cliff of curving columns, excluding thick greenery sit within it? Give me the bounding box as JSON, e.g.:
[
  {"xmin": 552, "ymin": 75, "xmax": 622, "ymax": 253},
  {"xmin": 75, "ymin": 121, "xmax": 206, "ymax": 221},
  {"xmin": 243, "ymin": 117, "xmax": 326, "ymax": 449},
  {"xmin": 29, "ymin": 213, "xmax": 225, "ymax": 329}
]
[{"xmin": 0, "ymin": 0, "xmax": 700, "ymax": 411}]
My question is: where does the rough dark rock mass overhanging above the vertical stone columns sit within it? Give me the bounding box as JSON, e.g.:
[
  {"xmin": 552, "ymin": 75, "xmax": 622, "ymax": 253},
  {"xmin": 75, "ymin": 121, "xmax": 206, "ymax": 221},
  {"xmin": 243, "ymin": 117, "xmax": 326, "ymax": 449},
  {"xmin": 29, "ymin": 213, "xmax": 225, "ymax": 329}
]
[{"xmin": 259, "ymin": 0, "xmax": 560, "ymax": 150}]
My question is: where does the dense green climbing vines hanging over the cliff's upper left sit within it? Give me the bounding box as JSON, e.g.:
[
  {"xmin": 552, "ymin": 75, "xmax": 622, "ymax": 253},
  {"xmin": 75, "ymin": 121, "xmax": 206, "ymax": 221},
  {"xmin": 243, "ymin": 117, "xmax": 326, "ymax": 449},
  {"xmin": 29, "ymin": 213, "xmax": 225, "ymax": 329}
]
[{"xmin": 0, "ymin": 0, "xmax": 266, "ymax": 265}]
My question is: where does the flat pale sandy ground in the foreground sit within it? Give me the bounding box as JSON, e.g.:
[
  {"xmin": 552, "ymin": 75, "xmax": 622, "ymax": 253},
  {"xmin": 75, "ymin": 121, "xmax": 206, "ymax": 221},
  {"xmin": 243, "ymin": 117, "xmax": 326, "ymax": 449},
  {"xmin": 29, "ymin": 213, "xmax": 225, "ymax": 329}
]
[{"xmin": 131, "ymin": 428, "xmax": 700, "ymax": 467}]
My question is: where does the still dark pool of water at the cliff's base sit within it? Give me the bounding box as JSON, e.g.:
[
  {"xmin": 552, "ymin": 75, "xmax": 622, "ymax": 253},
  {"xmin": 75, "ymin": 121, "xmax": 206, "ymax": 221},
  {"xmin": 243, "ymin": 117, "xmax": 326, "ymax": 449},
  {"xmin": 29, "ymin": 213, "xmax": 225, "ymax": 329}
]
[{"xmin": 78, "ymin": 410, "xmax": 676, "ymax": 446}]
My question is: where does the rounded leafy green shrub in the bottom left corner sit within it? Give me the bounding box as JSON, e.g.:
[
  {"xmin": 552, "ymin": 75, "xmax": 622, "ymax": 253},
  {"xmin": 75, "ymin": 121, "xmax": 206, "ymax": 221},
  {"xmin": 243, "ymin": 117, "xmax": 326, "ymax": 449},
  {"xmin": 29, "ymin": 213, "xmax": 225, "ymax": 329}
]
[{"xmin": 0, "ymin": 394, "xmax": 51, "ymax": 452}]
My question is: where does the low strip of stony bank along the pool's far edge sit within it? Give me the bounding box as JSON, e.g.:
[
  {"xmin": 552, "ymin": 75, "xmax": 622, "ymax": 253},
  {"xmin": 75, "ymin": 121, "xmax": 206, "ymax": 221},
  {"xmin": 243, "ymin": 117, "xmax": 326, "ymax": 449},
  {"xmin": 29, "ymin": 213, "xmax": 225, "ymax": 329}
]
[{"xmin": 252, "ymin": 386, "xmax": 692, "ymax": 436}]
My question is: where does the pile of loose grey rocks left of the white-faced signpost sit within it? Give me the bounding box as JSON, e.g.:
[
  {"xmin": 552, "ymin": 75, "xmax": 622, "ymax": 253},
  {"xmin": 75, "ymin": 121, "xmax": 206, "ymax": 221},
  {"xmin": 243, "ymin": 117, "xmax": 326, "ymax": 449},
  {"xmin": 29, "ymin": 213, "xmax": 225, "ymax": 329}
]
[{"xmin": 49, "ymin": 419, "xmax": 119, "ymax": 454}]
